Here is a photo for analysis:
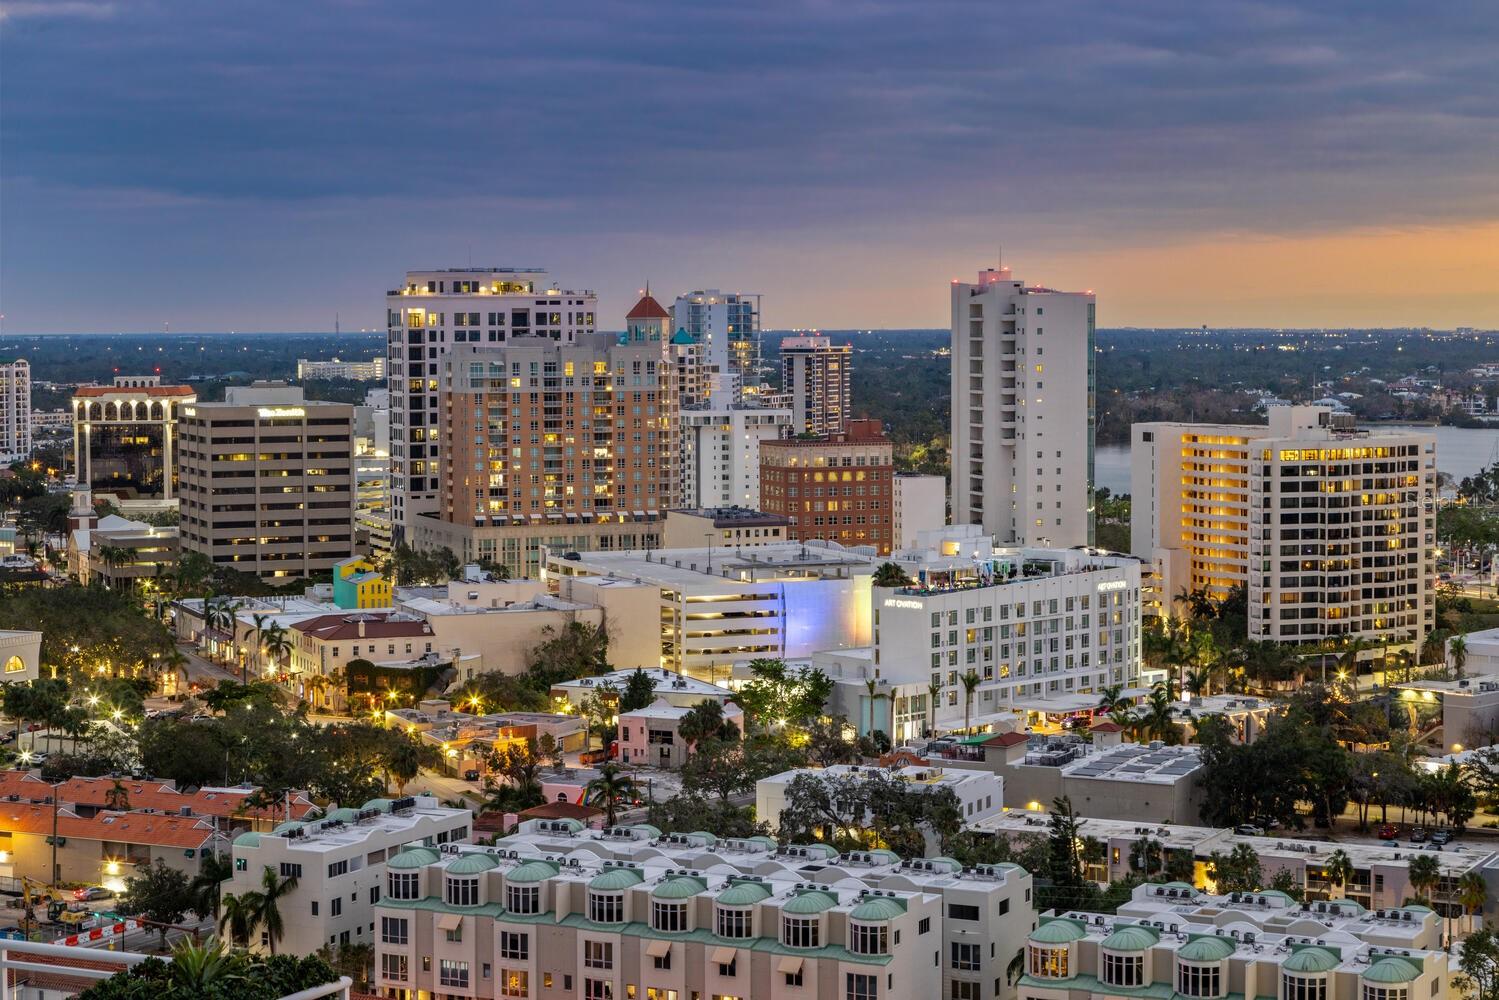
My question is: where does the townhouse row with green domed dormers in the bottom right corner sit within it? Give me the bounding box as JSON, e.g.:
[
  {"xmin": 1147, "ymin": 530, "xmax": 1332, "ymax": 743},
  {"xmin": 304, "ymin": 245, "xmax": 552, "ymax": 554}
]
[{"xmin": 1019, "ymin": 883, "xmax": 1453, "ymax": 1000}]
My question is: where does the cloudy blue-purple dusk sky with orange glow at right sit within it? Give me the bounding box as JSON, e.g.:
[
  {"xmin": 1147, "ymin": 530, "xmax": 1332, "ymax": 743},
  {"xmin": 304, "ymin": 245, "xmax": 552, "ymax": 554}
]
[{"xmin": 0, "ymin": 0, "xmax": 1499, "ymax": 333}]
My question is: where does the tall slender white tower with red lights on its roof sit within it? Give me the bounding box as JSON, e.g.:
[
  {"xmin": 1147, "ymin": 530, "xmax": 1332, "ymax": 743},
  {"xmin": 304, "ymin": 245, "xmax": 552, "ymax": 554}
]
[{"xmin": 952, "ymin": 267, "xmax": 1096, "ymax": 547}]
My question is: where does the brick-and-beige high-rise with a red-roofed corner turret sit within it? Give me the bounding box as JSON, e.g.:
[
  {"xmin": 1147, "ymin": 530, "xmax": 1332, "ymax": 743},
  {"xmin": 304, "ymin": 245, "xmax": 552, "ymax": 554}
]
[{"xmin": 412, "ymin": 295, "xmax": 678, "ymax": 574}]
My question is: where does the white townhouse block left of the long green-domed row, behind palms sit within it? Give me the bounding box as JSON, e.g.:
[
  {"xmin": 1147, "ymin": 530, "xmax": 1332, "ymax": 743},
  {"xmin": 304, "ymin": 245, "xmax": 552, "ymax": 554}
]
[{"xmin": 223, "ymin": 795, "xmax": 474, "ymax": 955}]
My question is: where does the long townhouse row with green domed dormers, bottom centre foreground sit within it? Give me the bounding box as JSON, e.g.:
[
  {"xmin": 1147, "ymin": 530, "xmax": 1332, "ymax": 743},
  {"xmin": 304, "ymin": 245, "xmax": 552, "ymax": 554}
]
[{"xmin": 375, "ymin": 820, "xmax": 1034, "ymax": 1000}]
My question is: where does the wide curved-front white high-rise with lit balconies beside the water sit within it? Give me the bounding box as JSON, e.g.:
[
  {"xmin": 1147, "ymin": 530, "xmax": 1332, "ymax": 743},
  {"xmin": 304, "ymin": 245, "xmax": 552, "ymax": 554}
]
[{"xmin": 1130, "ymin": 406, "xmax": 1436, "ymax": 646}]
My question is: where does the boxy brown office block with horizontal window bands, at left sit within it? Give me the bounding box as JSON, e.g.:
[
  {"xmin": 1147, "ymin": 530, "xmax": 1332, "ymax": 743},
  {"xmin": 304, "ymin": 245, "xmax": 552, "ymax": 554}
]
[{"xmin": 177, "ymin": 382, "xmax": 354, "ymax": 577}]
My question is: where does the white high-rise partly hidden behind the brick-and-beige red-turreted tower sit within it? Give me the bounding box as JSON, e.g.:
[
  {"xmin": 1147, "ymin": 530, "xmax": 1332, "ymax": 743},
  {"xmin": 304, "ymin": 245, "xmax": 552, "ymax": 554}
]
[{"xmin": 385, "ymin": 267, "xmax": 595, "ymax": 537}]
